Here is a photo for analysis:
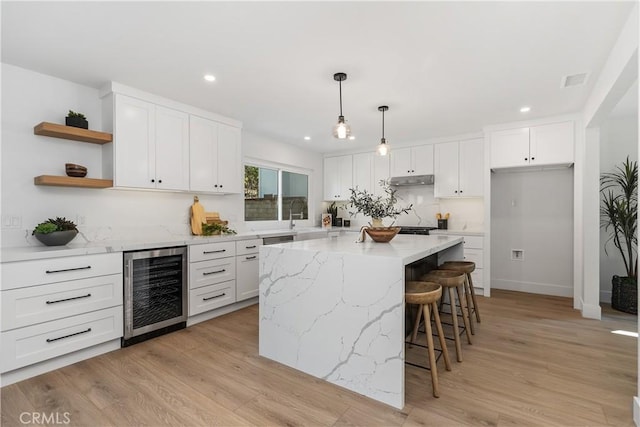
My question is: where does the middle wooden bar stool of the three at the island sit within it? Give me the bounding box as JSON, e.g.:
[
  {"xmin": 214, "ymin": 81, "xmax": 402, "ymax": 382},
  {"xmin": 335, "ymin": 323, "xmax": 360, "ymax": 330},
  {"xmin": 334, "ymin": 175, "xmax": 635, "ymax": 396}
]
[{"xmin": 420, "ymin": 270, "xmax": 473, "ymax": 362}]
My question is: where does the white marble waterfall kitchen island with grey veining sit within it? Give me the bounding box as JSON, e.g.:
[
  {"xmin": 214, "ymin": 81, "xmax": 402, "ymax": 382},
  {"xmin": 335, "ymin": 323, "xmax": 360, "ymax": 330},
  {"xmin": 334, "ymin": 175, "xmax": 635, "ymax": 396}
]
[{"xmin": 259, "ymin": 235, "xmax": 463, "ymax": 409}]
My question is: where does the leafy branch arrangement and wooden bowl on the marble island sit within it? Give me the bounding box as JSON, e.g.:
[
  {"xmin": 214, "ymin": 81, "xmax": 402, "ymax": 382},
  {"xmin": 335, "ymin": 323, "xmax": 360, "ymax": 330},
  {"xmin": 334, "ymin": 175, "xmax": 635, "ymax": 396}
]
[{"xmin": 349, "ymin": 180, "xmax": 413, "ymax": 242}]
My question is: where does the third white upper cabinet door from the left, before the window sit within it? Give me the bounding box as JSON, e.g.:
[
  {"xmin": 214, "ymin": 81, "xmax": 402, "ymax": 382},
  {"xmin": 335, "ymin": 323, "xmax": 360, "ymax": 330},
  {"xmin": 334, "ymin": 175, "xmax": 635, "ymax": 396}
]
[{"xmin": 189, "ymin": 116, "xmax": 218, "ymax": 192}]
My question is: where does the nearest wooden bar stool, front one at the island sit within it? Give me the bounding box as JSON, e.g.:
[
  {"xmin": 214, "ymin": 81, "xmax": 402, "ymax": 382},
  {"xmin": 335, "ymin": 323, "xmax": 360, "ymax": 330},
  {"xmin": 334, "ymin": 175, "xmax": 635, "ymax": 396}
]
[{"xmin": 404, "ymin": 281, "xmax": 451, "ymax": 397}]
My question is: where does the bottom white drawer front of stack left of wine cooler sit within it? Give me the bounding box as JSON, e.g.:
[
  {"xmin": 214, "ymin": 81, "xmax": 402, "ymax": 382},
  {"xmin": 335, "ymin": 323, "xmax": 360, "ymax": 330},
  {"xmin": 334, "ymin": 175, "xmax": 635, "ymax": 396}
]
[{"xmin": 0, "ymin": 307, "xmax": 123, "ymax": 372}]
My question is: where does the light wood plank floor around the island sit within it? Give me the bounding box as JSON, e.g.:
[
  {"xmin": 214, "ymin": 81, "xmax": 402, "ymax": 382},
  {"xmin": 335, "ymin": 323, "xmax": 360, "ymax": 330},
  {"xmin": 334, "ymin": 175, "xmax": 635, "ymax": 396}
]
[{"xmin": 1, "ymin": 291, "xmax": 637, "ymax": 426}]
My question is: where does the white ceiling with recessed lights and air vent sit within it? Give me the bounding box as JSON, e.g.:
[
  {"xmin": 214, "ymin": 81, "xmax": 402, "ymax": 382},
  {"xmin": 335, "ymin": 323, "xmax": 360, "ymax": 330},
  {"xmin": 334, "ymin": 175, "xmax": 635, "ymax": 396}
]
[{"xmin": 1, "ymin": 1, "xmax": 634, "ymax": 152}]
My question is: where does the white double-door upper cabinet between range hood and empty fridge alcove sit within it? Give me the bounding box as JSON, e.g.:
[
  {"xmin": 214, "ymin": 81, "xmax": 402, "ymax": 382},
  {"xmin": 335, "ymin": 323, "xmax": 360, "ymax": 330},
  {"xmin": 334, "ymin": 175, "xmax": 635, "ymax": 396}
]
[{"xmin": 434, "ymin": 138, "xmax": 484, "ymax": 198}]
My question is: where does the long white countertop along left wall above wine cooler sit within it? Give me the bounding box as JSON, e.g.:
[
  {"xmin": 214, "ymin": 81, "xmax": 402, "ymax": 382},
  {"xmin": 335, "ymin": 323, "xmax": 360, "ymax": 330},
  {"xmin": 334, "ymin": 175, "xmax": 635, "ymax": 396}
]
[{"xmin": 0, "ymin": 227, "xmax": 348, "ymax": 263}]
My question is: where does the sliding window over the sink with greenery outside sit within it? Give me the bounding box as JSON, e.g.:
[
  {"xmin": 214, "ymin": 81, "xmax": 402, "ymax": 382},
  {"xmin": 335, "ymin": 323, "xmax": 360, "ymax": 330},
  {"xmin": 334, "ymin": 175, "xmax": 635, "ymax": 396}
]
[{"xmin": 244, "ymin": 164, "xmax": 309, "ymax": 221}]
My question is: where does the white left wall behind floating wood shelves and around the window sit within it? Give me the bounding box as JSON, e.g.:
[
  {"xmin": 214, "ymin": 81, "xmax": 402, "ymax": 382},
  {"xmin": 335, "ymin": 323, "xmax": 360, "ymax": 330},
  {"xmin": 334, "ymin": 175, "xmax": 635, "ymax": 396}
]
[{"xmin": 1, "ymin": 64, "xmax": 322, "ymax": 247}]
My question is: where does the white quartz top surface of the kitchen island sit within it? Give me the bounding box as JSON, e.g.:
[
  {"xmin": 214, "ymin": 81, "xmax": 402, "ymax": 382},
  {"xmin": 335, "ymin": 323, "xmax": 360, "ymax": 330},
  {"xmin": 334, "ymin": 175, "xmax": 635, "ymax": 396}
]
[{"xmin": 267, "ymin": 234, "xmax": 462, "ymax": 265}]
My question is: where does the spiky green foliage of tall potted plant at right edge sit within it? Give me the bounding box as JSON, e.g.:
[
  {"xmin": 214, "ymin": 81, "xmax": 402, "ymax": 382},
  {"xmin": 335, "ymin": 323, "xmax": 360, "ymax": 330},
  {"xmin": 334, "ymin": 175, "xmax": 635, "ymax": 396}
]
[{"xmin": 600, "ymin": 156, "xmax": 638, "ymax": 278}]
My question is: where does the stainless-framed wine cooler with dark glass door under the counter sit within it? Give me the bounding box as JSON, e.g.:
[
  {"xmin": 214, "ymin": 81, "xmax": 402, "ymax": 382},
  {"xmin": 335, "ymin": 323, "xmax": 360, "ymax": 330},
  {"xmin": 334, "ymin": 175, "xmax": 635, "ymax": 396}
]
[{"xmin": 122, "ymin": 246, "xmax": 187, "ymax": 347}]
